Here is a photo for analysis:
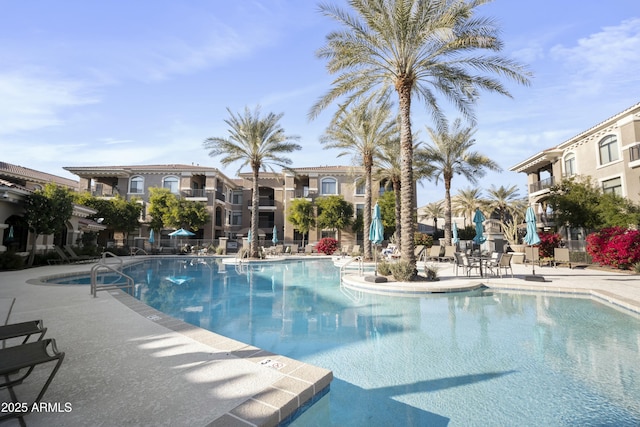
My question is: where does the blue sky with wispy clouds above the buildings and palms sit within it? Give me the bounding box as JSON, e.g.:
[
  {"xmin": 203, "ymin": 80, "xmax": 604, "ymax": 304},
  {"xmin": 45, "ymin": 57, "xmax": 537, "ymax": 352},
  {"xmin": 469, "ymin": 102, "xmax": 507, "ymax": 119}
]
[{"xmin": 0, "ymin": 0, "xmax": 640, "ymax": 205}]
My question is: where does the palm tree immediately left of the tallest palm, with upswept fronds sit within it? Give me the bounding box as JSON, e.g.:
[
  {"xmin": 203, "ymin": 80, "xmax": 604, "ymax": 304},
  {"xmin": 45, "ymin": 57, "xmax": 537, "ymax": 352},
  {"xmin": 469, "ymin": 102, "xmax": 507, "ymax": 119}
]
[{"xmin": 320, "ymin": 99, "xmax": 398, "ymax": 259}]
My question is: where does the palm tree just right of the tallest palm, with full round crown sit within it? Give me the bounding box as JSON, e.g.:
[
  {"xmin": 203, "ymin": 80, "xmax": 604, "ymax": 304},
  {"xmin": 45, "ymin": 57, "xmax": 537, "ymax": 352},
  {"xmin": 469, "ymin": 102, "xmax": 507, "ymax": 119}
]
[{"xmin": 416, "ymin": 119, "xmax": 501, "ymax": 245}]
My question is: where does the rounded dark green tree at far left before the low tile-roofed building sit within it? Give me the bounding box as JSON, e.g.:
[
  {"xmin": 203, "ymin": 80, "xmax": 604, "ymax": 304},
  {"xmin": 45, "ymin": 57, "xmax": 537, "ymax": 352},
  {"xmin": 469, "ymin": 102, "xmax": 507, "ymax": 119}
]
[{"xmin": 24, "ymin": 184, "xmax": 73, "ymax": 266}]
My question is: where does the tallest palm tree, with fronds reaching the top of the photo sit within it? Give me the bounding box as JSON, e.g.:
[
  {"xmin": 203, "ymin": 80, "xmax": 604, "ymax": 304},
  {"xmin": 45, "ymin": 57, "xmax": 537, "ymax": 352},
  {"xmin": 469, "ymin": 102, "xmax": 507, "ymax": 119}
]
[{"xmin": 310, "ymin": 0, "xmax": 528, "ymax": 276}]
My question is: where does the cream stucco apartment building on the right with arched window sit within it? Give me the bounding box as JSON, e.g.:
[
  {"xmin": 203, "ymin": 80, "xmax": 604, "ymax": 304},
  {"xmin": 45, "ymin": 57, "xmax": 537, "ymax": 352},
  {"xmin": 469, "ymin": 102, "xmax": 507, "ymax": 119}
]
[{"xmin": 510, "ymin": 103, "xmax": 640, "ymax": 240}]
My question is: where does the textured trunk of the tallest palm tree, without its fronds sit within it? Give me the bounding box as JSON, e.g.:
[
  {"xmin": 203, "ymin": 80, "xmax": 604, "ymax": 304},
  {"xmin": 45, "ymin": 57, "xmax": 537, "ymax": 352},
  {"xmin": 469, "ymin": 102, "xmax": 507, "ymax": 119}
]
[{"xmin": 396, "ymin": 81, "xmax": 417, "ymax": 272}]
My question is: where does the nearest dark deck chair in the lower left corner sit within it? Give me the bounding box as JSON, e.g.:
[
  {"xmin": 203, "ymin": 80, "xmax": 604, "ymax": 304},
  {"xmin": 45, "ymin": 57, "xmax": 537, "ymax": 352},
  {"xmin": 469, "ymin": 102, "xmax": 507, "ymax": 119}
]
[{"xmin": 0, "ymin": 338, "xmax": 64, "ymax": 425}]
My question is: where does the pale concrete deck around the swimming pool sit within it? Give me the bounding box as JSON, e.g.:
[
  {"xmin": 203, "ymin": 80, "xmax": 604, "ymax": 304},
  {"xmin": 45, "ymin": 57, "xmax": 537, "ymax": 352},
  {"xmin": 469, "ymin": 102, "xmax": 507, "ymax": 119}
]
[{"xmin": 0, "ymin": 257, "xmax": 640, "ymax": 427}]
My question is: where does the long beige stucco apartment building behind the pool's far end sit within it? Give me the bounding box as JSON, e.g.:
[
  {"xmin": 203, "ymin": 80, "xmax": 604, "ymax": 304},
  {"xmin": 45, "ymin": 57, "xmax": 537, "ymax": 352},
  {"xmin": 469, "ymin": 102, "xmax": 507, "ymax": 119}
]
[{"xmin": 64, "ymin": 165, "xmax": 380, "ymax": 251}]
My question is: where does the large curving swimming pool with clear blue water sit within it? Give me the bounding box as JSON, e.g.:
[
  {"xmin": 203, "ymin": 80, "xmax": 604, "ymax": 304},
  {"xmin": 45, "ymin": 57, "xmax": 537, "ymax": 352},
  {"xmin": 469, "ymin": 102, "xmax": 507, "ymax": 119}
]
[{"xmin": 128, "ymin": 258, "xmax": 640, "ymax": 426}]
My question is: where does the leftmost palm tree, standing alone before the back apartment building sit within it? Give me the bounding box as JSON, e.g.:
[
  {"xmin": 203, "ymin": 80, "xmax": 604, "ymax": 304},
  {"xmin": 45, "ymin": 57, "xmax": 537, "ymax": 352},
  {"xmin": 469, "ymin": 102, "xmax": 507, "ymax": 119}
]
[{"xmin": 204, "ymin": 106, "xmax": 302, "ymax": 258}]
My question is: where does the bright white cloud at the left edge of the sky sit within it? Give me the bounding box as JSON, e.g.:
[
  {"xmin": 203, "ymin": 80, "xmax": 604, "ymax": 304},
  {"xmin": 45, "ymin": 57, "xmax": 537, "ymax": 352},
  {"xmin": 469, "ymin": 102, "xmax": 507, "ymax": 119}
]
[{"xmin": 0, "ymin": 73, "xmax": 98, "ymax": 135}]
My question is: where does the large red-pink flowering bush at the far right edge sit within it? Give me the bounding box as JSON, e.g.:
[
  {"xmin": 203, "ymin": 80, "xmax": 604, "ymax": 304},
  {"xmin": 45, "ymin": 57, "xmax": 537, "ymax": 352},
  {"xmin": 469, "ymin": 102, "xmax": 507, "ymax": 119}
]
[{"xmin": 587, "ymin": 227, "xmax": 640, "ymax": 269}]
